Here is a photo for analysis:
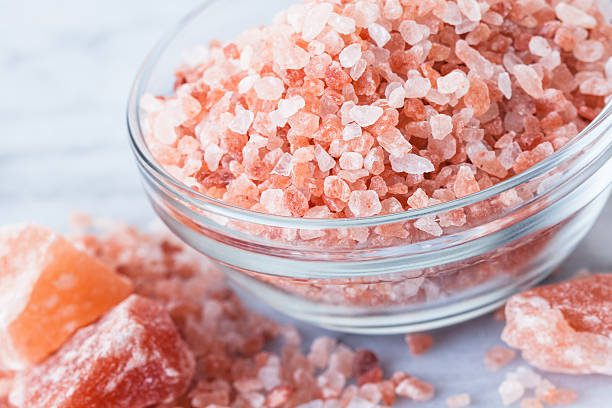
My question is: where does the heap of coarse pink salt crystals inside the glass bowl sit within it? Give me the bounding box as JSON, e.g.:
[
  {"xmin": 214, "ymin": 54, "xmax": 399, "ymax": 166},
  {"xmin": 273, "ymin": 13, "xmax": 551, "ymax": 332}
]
[{"xmin": 141, "ymin": 0, "xmax": 612, "ymax": 235}]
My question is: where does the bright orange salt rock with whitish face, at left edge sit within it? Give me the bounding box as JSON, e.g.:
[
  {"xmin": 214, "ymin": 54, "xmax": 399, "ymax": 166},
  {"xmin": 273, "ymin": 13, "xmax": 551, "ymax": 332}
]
[{"xmin": 0, "ymin": 226, "xmax": 132, "ymax": 370}]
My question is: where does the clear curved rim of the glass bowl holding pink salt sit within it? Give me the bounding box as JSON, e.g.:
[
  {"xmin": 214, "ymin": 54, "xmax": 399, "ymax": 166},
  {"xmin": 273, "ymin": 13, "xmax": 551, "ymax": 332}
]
[{"xmin": 127, "ymin": 0, "xmax": 612, "ymax": 229}]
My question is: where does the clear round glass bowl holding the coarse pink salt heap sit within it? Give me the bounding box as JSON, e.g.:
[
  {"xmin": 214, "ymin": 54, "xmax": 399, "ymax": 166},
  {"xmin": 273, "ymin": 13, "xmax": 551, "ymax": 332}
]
[{"xmin": 128, "ymin": 0, "xmax": 612, "ymax": 334}]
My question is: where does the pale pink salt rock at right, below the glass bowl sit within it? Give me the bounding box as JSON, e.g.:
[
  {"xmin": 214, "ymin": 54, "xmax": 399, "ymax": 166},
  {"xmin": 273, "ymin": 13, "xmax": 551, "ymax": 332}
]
[{"xmin": 502, "ymin": 274, "xmax": 612, "ymax": 375}]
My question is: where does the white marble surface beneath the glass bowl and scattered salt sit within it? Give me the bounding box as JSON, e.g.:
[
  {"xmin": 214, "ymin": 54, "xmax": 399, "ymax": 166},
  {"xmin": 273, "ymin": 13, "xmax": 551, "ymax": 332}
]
[{"xmin": 0, "ymin": 0, "xmax": 612, "ymax": 408}]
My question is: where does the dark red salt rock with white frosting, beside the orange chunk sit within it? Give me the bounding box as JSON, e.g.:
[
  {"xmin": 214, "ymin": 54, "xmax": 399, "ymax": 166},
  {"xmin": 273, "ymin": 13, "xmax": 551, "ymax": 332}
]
[{"xmin": 10, "ymin": 295, "xmax": 195, "ymax": 408}]
